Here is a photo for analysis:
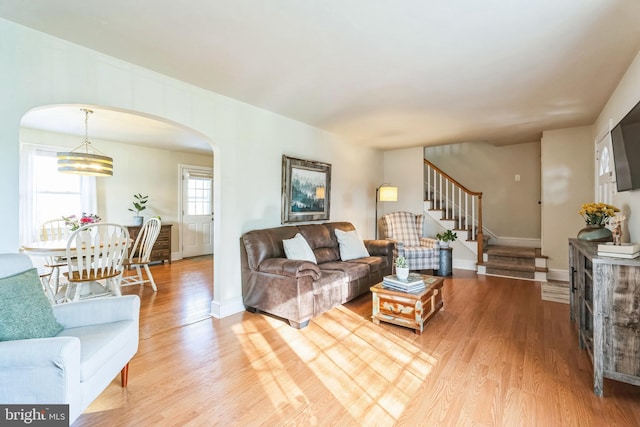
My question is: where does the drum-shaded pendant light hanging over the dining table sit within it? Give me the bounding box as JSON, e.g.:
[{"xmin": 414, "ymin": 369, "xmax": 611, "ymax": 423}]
[{"xmin": 57, "ymin": 108, "xmax": 113, "ymax": 176}]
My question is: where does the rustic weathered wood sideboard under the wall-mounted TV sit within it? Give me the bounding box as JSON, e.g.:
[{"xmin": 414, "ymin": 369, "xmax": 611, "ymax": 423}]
[{"xmin": 569, "ymin": 239, "xmax": 640, "ymax": 396}]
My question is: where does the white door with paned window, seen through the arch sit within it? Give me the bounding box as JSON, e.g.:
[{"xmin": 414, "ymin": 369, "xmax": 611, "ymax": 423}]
[{"xmin": 182, "ymin": 166, "xmax": 213, "ymax": 258}]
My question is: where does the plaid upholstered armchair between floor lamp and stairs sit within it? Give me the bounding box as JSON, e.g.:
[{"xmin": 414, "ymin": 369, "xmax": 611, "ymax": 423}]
[{"xmin": 382, "ymin": 212, "xmax": 440, "ymax": 270}]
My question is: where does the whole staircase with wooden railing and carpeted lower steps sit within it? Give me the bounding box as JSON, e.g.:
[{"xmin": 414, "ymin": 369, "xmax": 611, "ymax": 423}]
[{"xmin": 424, "ymin": 159, "xmax": 547, "ymax": 282}]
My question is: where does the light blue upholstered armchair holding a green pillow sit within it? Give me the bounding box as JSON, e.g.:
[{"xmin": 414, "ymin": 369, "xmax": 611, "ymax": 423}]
[{"xmin": 0, "ymin": 254, "xmax": 140, "ymax": 423}]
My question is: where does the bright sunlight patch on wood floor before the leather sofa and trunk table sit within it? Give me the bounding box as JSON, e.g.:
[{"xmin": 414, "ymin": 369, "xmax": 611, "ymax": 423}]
[{"xmin": 236, "ymin": 306, "xmax": 437, "ymax": 425}]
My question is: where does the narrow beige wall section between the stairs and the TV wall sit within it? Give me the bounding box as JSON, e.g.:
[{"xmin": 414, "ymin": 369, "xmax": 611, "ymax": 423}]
[{"xmin": 541, "ymin": 126, "xmax": 594, "ymax": 274}]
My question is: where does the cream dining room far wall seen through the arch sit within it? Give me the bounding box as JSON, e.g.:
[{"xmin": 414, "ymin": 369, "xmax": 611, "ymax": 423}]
[{"xmin": 20, "ymin": 128, "xmax": 213, "ymax": 259}]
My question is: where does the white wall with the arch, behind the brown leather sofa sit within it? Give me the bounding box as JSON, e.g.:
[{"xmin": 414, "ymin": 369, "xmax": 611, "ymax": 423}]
[{"xmin": 0, "ymin": 19, "xmax": 382, "ymax": 317}]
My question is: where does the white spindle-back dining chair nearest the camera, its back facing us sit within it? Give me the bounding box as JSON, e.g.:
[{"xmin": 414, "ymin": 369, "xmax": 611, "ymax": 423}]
[{"xmin": 64, "ymin": 223, "xmax": 129, "ymax": 301}]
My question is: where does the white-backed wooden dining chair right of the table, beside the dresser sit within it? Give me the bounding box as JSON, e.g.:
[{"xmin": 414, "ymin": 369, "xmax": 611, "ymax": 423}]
[{"xmin": 121, "ymin": 218, "xmax": 162, "ymax": 292}]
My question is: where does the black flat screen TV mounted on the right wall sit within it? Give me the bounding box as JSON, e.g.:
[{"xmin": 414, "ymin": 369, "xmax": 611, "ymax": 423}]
[{"xmin": 611, "ymin": 98, "xmax": 640, "ymax": 191}]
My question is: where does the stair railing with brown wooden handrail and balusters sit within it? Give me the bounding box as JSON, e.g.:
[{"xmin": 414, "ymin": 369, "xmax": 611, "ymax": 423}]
[{"xmin": 424, "ymin": 159, "xmax": 484, "ymax": 264}]
